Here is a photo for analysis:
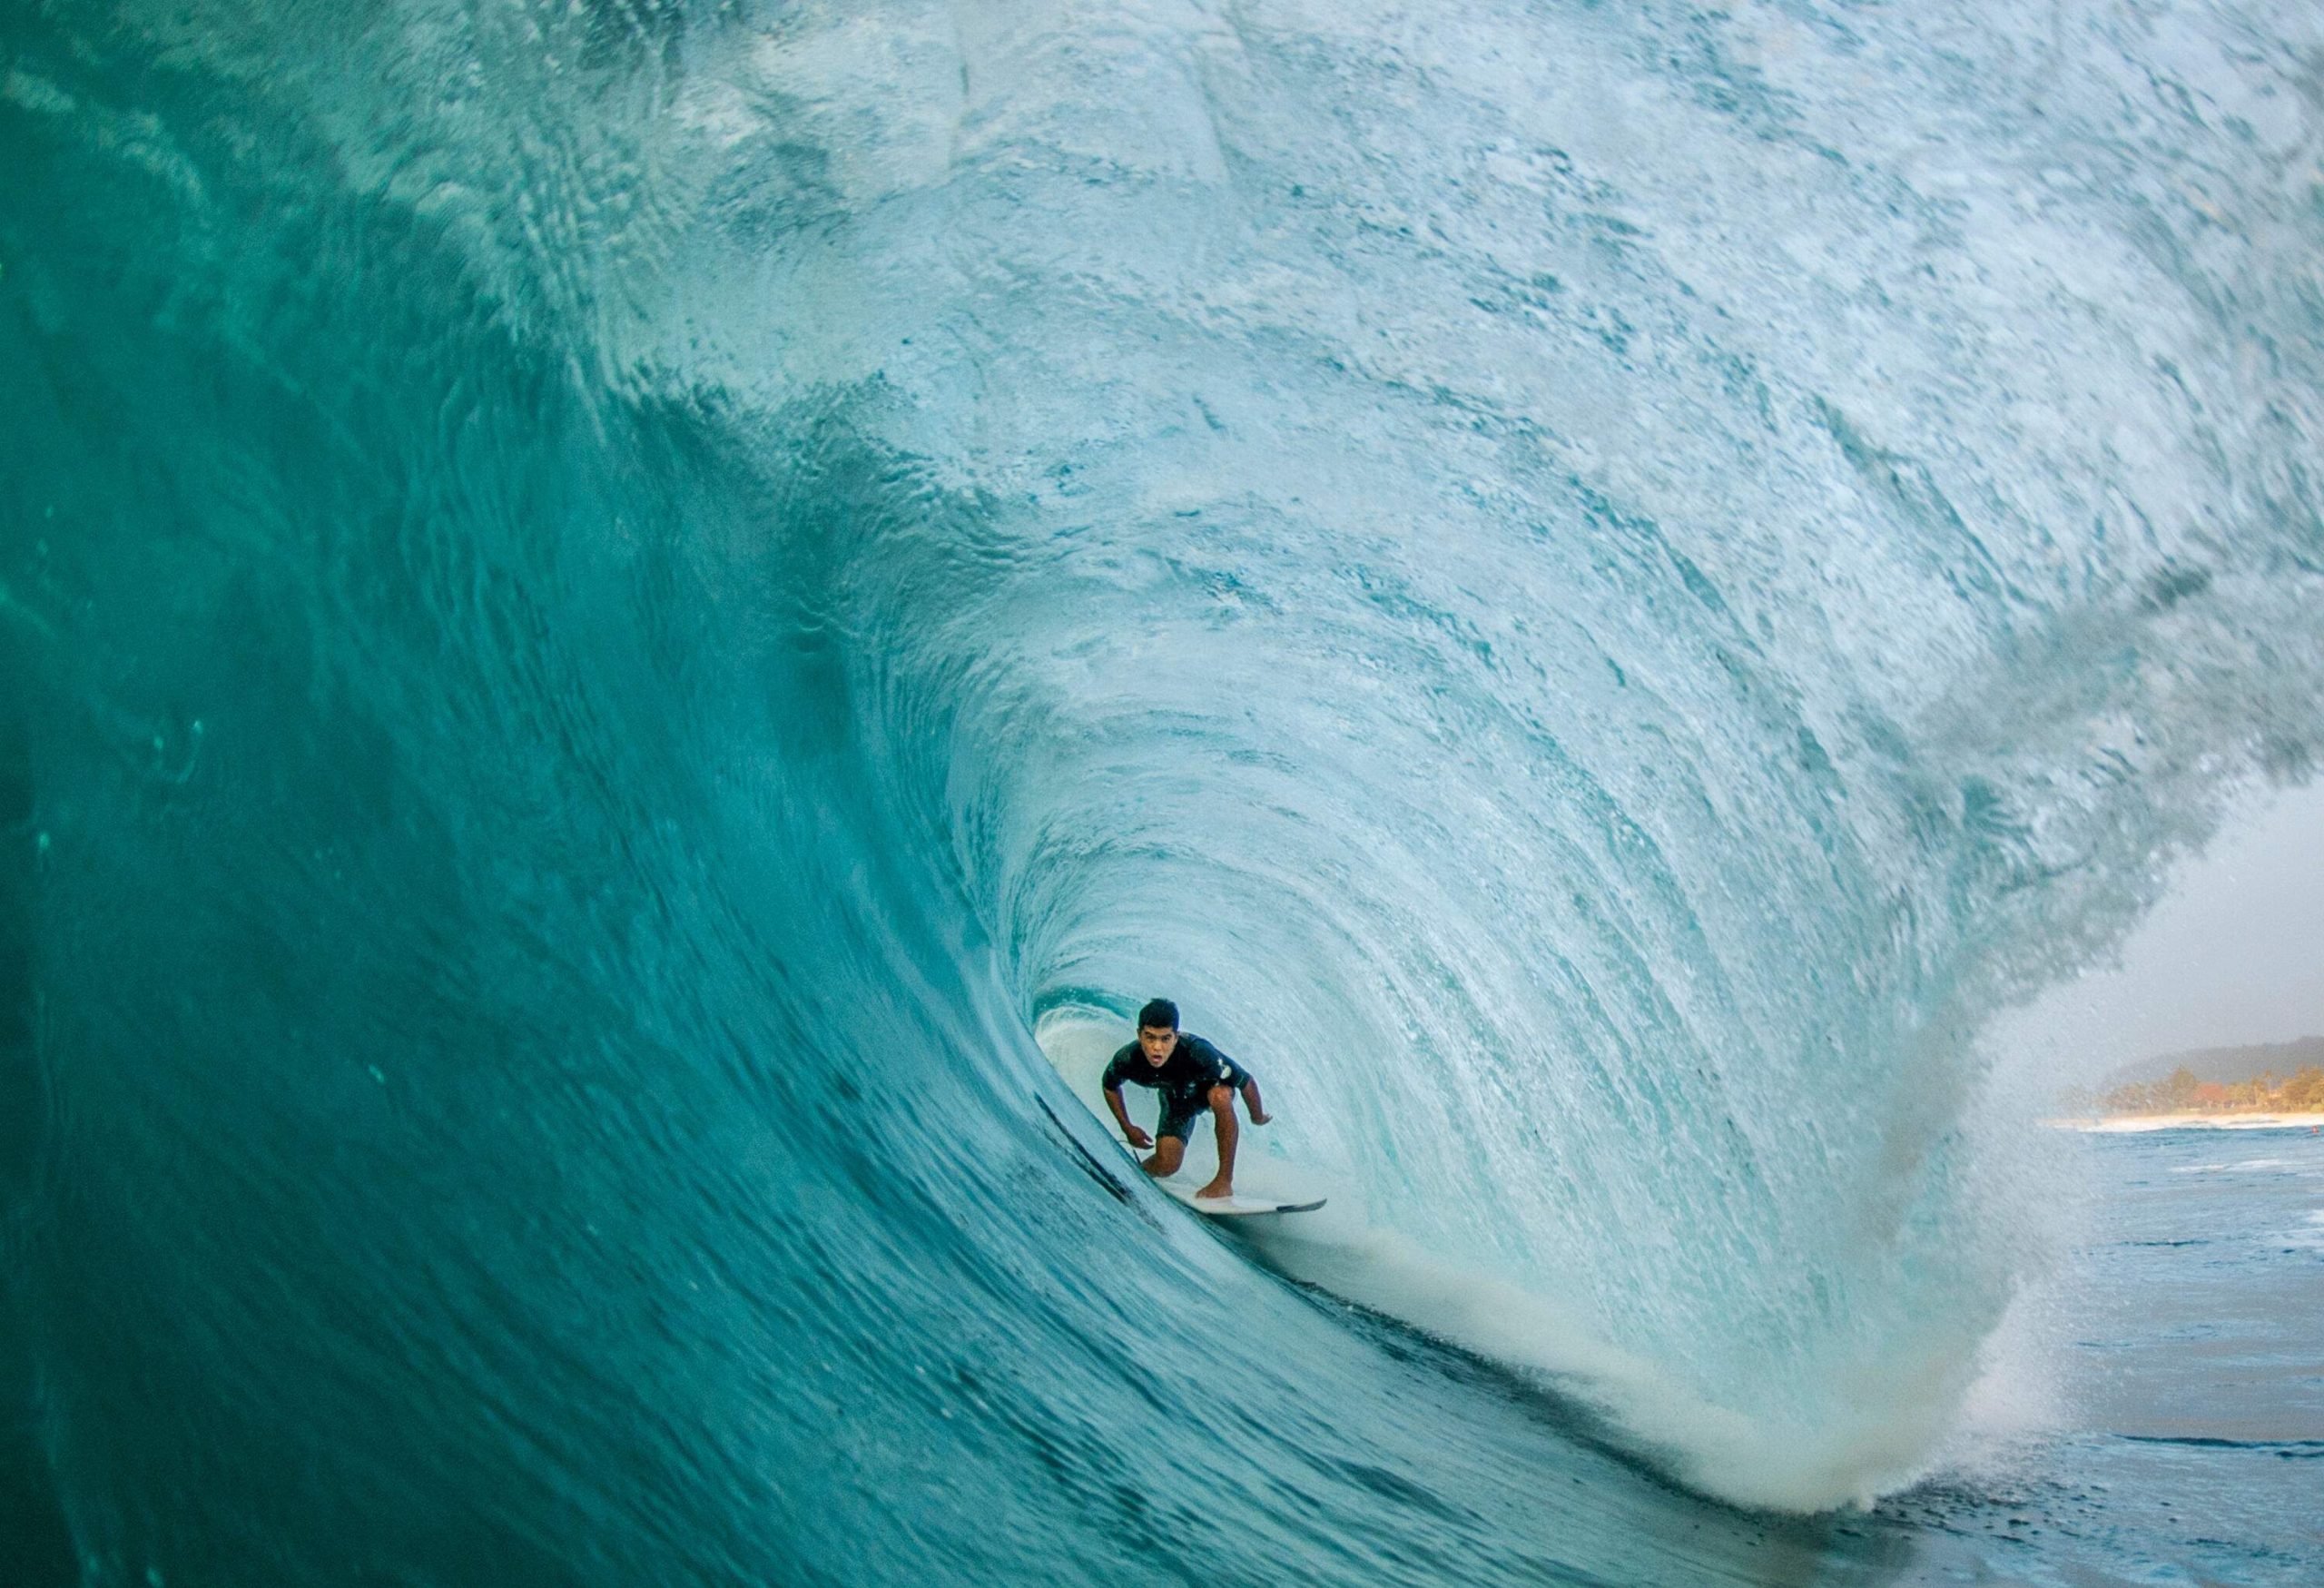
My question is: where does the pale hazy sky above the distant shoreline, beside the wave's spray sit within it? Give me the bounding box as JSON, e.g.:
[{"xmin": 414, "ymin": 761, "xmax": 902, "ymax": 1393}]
[{"xmin": 1989, "ymin": 784, "xmax": 2324, "ymax": 1086}]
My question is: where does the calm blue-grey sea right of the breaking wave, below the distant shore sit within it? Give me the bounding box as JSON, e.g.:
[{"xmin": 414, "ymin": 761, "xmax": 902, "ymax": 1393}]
[{"xmin": 1873, "ymin": 1125, "xmax": 2324, "ymax": 1585}]
